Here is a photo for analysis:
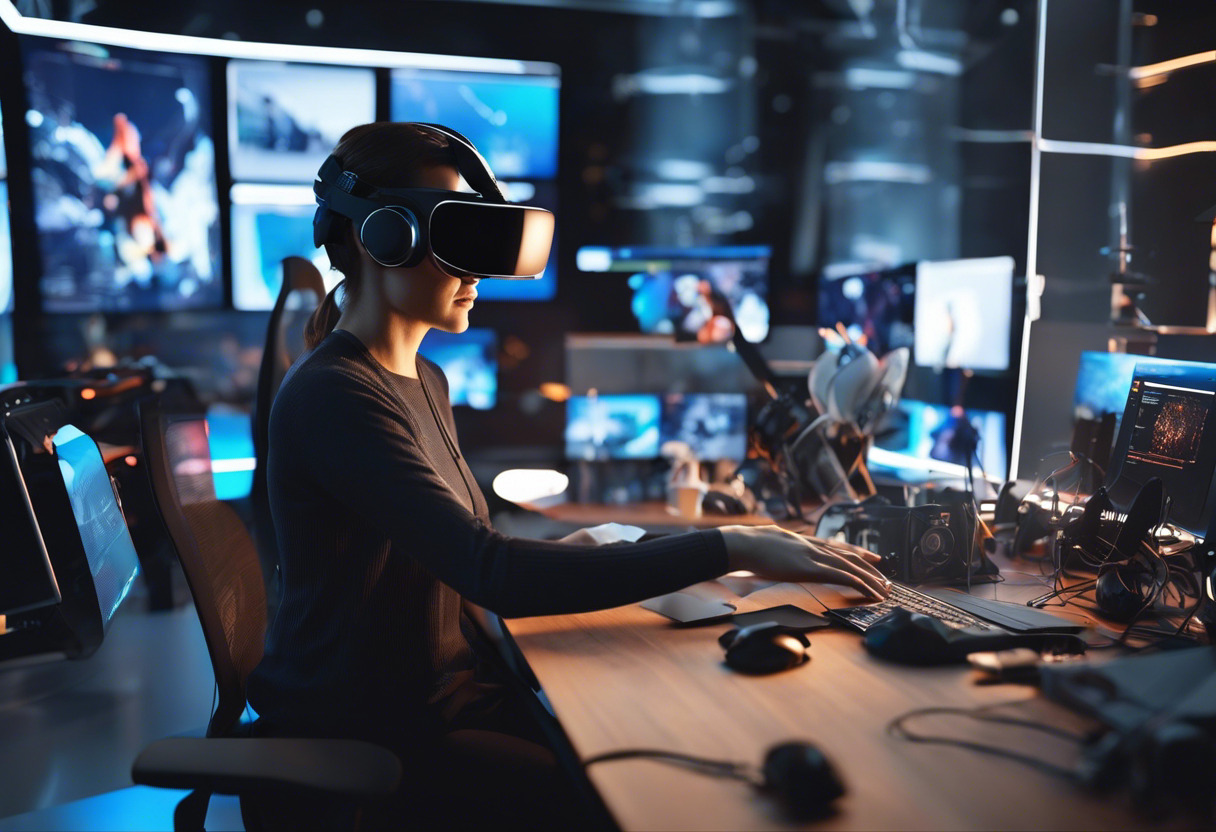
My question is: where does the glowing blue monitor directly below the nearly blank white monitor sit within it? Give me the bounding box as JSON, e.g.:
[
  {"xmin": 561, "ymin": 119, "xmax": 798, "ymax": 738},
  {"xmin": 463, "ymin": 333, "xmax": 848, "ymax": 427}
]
[{"xmin": 868, "ymin": 399, "xmax": 1008, "ymax": 482}]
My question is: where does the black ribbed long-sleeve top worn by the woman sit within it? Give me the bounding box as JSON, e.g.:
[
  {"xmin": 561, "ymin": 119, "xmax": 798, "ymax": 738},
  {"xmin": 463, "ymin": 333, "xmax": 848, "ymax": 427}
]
[{"xmin": 241, "ymin": 330, "xmax": 727, "ymax": 733}]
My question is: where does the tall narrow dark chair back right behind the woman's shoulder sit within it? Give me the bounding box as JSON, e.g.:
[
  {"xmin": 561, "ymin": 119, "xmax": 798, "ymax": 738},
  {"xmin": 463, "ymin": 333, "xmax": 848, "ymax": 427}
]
[{"xmin": 249, "ymin": 257, "xmax": 325, "ymax": 600}]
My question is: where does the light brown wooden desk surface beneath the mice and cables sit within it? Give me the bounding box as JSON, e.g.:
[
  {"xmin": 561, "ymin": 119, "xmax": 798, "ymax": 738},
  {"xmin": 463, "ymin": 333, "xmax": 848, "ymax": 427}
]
[{"xmin": 507, "ymin": 567, "xmax": 1167, "ymax": 830}]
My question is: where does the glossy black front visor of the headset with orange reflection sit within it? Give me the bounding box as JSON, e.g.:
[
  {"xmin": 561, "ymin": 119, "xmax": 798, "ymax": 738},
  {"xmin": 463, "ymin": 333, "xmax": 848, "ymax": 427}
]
[{"xmin": 429, "ymin": 201, "xmax": 553, "ymax": 277}]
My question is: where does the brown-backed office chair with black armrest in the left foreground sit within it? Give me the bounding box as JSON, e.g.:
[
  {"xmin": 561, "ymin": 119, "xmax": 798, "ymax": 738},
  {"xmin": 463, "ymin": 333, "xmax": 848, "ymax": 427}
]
[{"xmin": 131, "ymin": 400, "xmax": 401, "ymax": 830}]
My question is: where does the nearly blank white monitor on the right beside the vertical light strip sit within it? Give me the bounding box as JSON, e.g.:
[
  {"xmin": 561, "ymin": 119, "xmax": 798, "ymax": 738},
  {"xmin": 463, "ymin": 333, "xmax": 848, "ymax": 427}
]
[{"xmin": 913, "ymin": 257, "xmax": 1014, "ymax": 371}]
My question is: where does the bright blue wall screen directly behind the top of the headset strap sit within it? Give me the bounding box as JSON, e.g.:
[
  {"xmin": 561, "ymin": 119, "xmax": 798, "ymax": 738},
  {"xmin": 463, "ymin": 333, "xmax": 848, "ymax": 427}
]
[{"xmin": 390, "ymin": 69, "xmax": 561, "ymax": 180}]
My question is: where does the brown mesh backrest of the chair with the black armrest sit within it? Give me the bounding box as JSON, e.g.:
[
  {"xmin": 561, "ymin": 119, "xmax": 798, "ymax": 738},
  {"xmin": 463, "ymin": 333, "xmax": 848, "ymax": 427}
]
[{"xmin": 140, "ymin": 400, "xmax": 266, "ymax": 736}]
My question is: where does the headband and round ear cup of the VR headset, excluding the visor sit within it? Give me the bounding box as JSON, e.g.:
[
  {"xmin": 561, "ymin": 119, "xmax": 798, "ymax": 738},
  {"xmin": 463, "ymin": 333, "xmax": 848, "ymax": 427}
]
[{"xmin": 313, "ymin": 122, "xmax": 507, "ymax": 268}]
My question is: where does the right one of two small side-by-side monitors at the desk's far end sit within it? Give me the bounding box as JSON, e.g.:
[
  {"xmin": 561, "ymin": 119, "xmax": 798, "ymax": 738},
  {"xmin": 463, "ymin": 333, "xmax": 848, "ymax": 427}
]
[{"xmin": 659, "ymin": 393, "xmax": 748, "ymax": 462}]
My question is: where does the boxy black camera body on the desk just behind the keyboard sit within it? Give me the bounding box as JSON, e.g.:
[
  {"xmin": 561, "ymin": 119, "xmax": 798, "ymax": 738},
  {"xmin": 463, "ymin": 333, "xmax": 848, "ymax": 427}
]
[{"xmin": 818, "ymin": 502, "xmax": 989, "ymax": 584}]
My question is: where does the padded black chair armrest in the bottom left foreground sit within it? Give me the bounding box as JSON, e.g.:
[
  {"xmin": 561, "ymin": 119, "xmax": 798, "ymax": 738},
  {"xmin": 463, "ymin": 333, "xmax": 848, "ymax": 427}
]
[{"xmin": 131, "ymin": 737, "xmax": 401, "ymax": 798}]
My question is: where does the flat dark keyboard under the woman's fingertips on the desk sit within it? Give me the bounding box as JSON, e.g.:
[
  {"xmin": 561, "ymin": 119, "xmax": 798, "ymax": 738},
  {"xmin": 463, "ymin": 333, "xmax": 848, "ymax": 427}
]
[{"xmin": 826, "ymin": 583, "xmax": 1085, "ymax": 633}]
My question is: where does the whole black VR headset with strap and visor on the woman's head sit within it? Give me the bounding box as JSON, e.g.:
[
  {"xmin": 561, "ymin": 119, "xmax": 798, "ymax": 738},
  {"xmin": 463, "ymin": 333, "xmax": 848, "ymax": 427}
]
[{"xmin": 313, "ymin": 123, "xmax": 553, "ymax": 280}]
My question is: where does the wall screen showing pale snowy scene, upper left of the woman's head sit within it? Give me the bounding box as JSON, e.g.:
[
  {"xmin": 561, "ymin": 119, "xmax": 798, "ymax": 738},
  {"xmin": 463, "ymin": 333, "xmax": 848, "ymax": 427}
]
[{"xmin": 227, "ymin": 61, "xmax": 376, "ymax": 182}]
